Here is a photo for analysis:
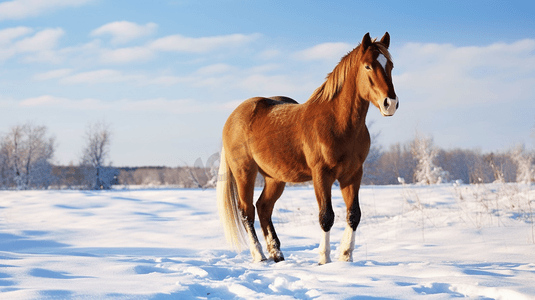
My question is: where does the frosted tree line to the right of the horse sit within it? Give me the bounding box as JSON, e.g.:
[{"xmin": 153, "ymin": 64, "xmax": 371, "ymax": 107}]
[{"xmin": 363, "ymin": 133, "xmax": 535, "ymax": 185}]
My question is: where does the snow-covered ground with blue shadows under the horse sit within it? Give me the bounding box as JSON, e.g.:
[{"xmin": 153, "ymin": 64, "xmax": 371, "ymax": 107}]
[{"xmin": 0, "ymin": 184, "xmax": 535, "ymax": 299}]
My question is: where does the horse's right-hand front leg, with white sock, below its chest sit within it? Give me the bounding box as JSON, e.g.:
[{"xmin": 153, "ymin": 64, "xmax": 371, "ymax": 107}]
[{"xmin": 339, "ymin": 168, "xmax": 362, "ymax": 261}]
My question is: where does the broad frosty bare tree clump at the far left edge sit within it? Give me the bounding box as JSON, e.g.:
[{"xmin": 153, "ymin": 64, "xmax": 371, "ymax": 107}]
[{"xmin": 0, "ymin": 123, "xmax": 55, "ymax": 189}]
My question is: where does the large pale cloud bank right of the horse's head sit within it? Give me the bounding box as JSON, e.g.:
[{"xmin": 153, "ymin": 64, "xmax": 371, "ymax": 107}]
[{"xmin": 368, "ymin": 39, "xmax": 535, "ymax": 149}]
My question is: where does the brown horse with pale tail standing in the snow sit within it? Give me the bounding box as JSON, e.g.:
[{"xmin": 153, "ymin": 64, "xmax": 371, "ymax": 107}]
[{"xmin": 217, "ymin": 32, "xmax": 399, "ymax": 264}]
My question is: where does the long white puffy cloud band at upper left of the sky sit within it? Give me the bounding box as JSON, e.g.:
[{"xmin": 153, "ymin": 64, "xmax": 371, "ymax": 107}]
[{"xmin": 0, "ymin": 21, "xmax": 259, "ymax": 66}]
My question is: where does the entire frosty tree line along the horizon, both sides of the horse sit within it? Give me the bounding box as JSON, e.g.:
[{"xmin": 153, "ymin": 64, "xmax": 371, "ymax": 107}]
[{"xmin": 0, "ymin": 122, "xmax": 535, "ymax": 190}]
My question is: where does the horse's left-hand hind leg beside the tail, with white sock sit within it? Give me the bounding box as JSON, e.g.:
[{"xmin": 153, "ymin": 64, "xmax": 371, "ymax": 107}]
[{"xmin": 236, "ymin": 169, "xmax": 266, "ymax": 262}]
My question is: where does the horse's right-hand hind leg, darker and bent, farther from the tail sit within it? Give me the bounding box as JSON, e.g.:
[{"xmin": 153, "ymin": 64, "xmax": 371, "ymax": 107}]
[{"xmin": 256, "ymin": 178, "xmax": 286, "ymax": 262}]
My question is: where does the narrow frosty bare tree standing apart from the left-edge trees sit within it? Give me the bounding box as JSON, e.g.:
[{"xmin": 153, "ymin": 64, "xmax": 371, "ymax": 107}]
[{"xmin": 81, "ymin": 121, "xmax": 116, "ymax": 189}]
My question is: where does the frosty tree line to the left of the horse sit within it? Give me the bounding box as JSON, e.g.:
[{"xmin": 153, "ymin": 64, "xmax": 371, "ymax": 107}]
[{"xmin": 0, "ymin": 121, "xmax": 221, "ymax": 190}]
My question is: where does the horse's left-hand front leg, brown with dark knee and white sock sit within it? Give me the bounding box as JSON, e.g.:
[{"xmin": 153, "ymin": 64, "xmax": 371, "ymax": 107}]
[{"xmin": 312, "ymin": 169, "xmax": 334, "ymax": 265}]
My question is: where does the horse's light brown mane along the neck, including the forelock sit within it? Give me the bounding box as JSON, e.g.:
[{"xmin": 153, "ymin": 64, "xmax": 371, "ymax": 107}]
[{"xmin": 309, "ymin": 39, "xmax": 392, "ymax": 103}]
